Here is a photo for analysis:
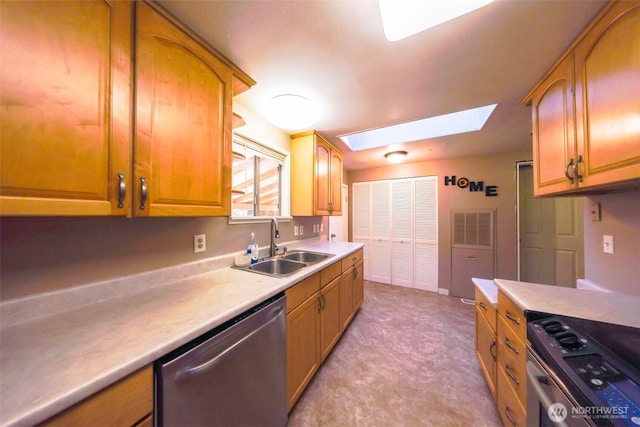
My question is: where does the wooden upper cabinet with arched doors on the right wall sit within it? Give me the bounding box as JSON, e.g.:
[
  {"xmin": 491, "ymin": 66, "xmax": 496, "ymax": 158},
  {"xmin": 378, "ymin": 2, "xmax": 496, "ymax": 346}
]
[{"xmin": 523, "ymin": 1, "xmax": 640, "ymax": 196}]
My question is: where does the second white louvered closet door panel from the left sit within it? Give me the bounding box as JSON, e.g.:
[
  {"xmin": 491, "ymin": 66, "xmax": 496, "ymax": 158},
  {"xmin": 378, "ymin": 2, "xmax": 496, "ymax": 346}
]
[{"xmin": 365, "ymin": 181, "xmax": 391, "ymax": 284}]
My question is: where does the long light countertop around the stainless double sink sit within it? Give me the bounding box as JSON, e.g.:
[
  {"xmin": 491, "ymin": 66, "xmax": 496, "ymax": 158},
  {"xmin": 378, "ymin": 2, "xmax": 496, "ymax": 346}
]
[{"xmin": 0, "ymin": 242, "xmax": 362, "ymax": 426}]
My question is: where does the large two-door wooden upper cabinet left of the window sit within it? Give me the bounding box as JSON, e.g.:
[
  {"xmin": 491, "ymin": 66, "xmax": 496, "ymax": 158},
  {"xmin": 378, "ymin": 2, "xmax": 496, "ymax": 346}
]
[{"xmin": 0, "ymin": 0, "xmax": 255, "ymax": 216}]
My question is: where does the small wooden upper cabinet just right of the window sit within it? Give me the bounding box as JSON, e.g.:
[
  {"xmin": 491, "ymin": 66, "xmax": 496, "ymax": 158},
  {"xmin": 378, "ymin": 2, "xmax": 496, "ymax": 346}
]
[{"xmin": 291, "ymin": 132, "xmax": 342, "ymax": 216}]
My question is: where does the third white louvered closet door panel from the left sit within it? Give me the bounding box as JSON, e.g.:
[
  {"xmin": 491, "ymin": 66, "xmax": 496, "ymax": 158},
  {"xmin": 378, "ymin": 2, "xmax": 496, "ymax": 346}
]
[{"xmin": 391, "ymin": 180, "xmax": 414, "ymax": 288}]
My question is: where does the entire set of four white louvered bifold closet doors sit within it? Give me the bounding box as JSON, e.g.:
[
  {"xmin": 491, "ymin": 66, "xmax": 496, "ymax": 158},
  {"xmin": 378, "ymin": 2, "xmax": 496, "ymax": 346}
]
[{"xmin": 352, "ymin": 177, "xmax": 438, "ymax": 292}]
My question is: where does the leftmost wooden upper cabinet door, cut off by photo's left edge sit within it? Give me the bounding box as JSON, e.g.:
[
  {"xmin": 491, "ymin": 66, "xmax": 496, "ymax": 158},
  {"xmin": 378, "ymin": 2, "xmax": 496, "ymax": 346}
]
[{"xmin": 0, "ymin": 1, "xmax": 132, "ymax": 215}]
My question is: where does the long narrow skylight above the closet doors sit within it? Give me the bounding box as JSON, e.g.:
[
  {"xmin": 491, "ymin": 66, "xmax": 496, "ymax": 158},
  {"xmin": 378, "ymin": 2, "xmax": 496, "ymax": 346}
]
[{"xmin": 340, "ymin": 104, "xmax": 498, "ymax": 151}]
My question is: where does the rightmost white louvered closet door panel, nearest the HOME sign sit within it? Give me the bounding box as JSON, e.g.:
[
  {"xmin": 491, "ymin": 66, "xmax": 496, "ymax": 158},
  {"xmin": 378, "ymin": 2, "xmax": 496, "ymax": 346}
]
[{"xmin": 413, "ymin": 176, "xmax": 438, "ymax": 292}]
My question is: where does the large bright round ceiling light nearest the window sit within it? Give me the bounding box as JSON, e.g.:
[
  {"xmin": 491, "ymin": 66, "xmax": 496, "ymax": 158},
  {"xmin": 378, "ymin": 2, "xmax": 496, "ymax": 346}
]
[{"xmin": 267, "ymin": 94, "xmax": 318, "ymax": 130}]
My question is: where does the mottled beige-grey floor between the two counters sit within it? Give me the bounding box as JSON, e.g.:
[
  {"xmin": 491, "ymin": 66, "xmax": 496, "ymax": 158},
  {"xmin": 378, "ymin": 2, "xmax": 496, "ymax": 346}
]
[{"xmin": 288, "ymin": 282, "xmax": 502, "ymax": 427}]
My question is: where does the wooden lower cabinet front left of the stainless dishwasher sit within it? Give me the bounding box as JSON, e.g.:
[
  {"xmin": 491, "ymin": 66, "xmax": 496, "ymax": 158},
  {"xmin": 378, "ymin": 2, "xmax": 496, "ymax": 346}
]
[{"xmin": 42, "ymin": 366, "xmax": 153, "ymax": 426}]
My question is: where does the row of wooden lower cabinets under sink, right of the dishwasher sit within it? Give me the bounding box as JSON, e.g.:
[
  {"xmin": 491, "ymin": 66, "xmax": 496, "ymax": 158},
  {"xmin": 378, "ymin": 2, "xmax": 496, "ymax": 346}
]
[{"xmin": 286, "ymin": 250, "xmax": 364, "ymax": 411}]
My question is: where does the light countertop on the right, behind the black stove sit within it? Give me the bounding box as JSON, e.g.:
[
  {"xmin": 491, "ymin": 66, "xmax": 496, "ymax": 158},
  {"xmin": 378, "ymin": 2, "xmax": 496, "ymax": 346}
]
[{"xmin": 494, "ymin": 279, "xmax": 640, "ymax": 328}]
